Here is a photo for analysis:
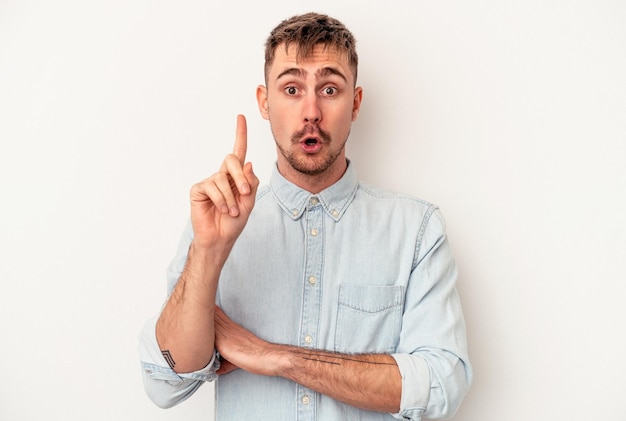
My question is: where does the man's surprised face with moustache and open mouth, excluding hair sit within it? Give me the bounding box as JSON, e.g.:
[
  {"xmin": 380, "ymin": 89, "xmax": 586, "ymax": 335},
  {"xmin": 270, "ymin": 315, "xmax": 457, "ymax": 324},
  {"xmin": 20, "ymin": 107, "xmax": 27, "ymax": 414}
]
[{"xmin": 257, "ymin": 45, "xmax": 362, "ymax": 180}]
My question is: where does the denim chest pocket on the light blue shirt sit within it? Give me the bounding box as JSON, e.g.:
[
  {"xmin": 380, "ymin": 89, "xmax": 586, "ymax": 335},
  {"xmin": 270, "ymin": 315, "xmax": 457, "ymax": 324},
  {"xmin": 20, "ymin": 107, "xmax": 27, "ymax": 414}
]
[{"xmin": 335, "ymin": 284, "xmax": 404, "ymax": 353}]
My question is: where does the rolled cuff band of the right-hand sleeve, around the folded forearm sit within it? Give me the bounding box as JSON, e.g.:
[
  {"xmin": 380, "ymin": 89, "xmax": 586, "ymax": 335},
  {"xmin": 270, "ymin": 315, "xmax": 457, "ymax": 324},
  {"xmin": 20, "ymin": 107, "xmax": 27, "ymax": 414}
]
[{"xmin": 392, "ymin": 354, "xmax": 430, "ymax": 420}]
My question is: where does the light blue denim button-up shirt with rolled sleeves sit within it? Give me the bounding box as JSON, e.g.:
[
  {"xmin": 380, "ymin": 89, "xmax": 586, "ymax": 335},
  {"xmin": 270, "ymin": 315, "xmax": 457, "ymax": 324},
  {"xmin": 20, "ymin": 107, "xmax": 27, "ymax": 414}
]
[{"xmin": 139, "ymin": 162, "xmax": 472, "ymax": 421}]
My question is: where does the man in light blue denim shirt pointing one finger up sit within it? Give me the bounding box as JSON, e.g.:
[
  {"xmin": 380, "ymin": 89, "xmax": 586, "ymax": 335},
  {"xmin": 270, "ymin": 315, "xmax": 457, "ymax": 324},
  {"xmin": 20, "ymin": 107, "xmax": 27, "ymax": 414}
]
[{"xmin": 140, "ymin": 13, "xmax": 471, "ymax": 421}]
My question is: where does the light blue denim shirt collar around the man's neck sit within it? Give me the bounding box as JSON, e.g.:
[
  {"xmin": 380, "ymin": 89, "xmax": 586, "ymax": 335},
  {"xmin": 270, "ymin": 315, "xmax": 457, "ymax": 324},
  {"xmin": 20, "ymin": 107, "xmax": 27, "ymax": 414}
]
[{"xmin": 270, "ymin": 161, "xmax": 359, "ymax": 222}]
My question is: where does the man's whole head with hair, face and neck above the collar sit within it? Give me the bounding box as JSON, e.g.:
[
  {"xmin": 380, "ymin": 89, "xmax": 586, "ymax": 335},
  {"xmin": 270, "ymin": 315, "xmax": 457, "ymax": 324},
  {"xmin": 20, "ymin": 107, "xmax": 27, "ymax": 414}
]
[{"xmin": 257, "ymin": 13, "xmax": 363, "ymax": 192}]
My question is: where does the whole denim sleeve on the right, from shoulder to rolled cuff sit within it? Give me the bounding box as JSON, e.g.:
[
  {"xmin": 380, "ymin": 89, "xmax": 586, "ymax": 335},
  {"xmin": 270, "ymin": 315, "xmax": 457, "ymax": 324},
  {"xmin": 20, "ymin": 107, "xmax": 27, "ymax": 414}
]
[{"xmin": 393, "ymin": 207, "xmax": 472, "ymax": 420}]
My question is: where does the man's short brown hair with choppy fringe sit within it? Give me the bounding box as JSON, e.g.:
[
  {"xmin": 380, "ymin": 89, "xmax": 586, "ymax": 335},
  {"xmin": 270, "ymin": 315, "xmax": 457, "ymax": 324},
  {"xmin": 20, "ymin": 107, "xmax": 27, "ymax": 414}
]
[{"xmin": 265, "ymin": 13, "xmax": 359, "ymax": 83}]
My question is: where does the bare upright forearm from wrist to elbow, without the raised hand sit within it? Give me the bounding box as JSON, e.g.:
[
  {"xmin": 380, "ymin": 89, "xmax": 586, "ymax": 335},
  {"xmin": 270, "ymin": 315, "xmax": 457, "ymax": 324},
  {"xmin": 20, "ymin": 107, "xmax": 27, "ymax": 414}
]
[{"xmin": 156, "ymin": 242, "xmax": 227, "ymax": 373}]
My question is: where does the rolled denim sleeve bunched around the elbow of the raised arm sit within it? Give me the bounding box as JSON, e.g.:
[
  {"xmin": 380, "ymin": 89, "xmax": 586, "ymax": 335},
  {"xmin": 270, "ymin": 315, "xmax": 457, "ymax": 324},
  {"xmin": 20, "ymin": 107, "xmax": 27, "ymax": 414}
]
[{"xmin": 139, "ymin": 317, "xmax": 219, "ymax": 408}]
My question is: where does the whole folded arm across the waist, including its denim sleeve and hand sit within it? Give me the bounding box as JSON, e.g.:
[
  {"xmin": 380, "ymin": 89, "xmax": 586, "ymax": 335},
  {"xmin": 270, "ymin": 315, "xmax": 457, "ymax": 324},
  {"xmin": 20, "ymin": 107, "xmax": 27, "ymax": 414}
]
[{"xmin": 215, "ymin": 207, "xmax": 472, "ymax": 420}]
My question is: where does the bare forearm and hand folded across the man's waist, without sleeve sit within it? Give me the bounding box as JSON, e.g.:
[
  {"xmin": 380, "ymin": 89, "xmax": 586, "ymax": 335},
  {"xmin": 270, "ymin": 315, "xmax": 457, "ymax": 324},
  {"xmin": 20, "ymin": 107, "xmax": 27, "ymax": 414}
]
[{"xmin": 215, "ymin": 308, "xmax": 402, "ymax": 413}]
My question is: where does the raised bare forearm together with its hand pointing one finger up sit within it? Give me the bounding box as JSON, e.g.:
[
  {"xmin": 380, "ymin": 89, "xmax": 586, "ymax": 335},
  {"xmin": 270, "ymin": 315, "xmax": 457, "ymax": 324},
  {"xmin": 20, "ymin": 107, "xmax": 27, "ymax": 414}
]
[{"xmin": 156, "ymin": 116, "xmax": 259, "ymax": 373}]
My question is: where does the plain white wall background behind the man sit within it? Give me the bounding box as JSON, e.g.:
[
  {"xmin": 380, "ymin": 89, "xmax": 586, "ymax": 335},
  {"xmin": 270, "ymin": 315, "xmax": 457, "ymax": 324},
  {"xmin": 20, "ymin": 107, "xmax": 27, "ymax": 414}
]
[{"xmin": 0, "ymin": 0, "xmax": 626, "ymax": 421}]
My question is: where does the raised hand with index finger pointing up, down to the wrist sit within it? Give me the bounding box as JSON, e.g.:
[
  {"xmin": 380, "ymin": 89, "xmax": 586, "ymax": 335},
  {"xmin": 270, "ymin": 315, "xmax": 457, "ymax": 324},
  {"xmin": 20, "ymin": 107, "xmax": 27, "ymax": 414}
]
[{"xmin": 190, "ymin": 115, "xmax": 259, "ymax": 252}]
